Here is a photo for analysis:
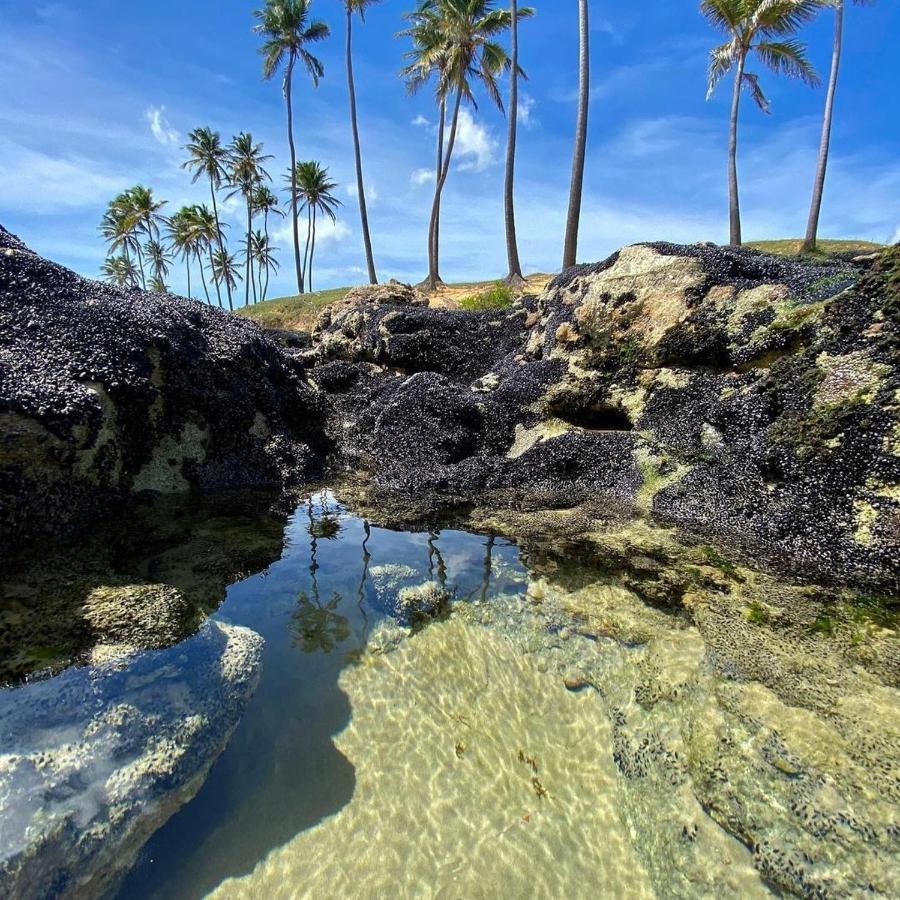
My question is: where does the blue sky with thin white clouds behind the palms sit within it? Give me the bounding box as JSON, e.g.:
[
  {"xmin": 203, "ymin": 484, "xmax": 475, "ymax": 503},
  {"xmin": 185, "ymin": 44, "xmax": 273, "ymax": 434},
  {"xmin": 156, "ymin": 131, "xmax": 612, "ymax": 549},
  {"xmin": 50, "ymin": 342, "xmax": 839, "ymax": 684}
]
[{"xmin": 0, "ymin": 0, "xmax": 900, "ymax": 295}]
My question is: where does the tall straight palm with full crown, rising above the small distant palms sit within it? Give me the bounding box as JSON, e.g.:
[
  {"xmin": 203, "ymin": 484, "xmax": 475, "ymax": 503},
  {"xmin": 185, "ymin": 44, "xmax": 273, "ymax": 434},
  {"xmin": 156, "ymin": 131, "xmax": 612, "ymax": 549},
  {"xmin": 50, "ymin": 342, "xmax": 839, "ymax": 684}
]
[{"xmin": 248, "ymin": 0, "xmax": 331, "ymax": 294}]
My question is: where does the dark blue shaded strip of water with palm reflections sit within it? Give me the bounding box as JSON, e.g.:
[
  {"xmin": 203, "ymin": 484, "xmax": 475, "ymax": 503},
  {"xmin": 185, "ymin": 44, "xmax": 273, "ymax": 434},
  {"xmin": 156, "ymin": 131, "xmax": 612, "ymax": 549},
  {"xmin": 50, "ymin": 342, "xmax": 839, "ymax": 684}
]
[{"xmin": 119, "ymin": 492, "xmax": 517, "ymax": 900}]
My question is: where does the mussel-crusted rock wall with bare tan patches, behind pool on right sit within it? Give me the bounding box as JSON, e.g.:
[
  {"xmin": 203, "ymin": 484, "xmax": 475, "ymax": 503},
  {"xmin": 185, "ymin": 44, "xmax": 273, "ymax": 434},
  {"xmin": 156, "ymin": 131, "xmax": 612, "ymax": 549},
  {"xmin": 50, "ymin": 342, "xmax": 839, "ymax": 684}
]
[{"xmin": 305, "ymin": 244, "xmax": 900, "ymax": 589}]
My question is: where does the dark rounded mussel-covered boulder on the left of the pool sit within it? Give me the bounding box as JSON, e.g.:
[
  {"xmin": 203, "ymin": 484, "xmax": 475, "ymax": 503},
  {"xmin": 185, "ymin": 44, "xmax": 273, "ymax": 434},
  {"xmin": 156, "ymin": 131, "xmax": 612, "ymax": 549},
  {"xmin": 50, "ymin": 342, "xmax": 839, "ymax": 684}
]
[{"xmin": 0, "ymin": 229, "xmax": 324, "ymax": 549}]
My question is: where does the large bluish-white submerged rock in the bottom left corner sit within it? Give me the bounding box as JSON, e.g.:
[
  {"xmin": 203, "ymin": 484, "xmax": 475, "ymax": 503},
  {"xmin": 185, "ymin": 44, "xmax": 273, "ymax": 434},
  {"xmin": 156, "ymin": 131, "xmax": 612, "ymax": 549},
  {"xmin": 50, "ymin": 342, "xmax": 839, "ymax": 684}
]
[{"xmin": 0, "ymin": 622, "xmax": 262, "ymax": 900}]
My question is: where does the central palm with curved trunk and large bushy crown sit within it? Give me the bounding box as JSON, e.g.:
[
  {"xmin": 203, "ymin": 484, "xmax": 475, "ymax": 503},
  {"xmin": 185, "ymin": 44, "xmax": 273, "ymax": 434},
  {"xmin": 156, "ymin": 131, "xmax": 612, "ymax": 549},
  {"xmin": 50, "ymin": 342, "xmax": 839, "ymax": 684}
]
[{"xmin": 402, "ymin": 0, "xmax": 534, "ymax": 289}]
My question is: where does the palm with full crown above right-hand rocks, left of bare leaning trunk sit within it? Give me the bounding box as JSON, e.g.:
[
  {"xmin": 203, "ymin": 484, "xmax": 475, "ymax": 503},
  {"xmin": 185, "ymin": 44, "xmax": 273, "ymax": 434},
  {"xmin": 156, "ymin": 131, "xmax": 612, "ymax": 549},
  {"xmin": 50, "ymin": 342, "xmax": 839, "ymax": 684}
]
[{"xmin": 700, "ymin": 0, "xmax": 831, "ymax": 247}]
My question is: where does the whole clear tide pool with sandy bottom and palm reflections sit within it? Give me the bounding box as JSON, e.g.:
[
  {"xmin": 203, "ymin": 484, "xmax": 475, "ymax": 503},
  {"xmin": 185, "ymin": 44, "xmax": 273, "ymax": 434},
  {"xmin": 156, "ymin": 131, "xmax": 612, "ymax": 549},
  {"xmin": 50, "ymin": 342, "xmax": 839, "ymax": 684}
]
[{"xmin": 0, "ymin": 491, "xmax": 900, "ymax": 898}]
